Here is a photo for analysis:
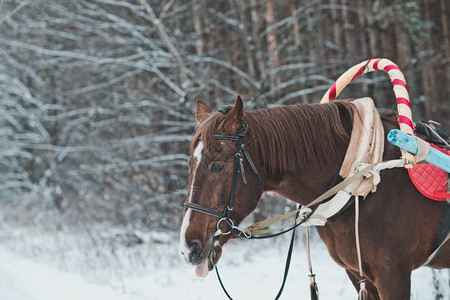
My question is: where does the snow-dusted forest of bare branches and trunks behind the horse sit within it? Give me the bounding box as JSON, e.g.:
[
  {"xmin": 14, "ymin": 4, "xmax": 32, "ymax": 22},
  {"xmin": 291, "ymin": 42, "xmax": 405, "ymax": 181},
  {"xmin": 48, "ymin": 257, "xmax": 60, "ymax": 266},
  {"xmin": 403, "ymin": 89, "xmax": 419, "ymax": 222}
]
[{"xmin": 0, "ymin": 0, "xmax": 450, "ymax": 230}]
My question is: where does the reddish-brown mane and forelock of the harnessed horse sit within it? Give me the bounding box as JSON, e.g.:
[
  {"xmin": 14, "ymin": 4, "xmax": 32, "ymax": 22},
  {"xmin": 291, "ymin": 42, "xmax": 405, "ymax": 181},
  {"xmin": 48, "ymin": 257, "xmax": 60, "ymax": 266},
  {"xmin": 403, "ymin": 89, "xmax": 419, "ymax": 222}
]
[{"xmin": 191, "ymin": 101, "xmax": 353, "ymax": 174}]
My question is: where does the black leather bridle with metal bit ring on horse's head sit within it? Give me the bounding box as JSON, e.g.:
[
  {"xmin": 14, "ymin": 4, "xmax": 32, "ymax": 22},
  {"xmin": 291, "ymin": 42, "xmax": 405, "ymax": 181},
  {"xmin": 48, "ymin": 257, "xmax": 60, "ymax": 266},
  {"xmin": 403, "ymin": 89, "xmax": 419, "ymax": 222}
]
[{"xmin": 183, "ymin": 113, "xmax": 264, "ymax": 236}]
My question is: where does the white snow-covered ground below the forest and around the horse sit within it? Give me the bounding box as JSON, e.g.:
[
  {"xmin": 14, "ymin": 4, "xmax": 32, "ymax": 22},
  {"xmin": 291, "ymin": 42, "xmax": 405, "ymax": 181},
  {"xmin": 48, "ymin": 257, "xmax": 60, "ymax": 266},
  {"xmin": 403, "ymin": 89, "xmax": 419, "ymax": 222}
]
[{"xmin": 0, "ymin": 228, "xmax": 450, "ymax": 300}]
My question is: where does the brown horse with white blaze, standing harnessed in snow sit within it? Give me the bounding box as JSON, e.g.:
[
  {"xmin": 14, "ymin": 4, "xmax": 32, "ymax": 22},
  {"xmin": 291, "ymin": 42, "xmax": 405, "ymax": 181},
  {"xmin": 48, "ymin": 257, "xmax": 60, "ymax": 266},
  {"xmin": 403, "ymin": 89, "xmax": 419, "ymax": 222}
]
[{"xmin": 180, "ymin": 97, "xmax": 450, "ymax": 300}]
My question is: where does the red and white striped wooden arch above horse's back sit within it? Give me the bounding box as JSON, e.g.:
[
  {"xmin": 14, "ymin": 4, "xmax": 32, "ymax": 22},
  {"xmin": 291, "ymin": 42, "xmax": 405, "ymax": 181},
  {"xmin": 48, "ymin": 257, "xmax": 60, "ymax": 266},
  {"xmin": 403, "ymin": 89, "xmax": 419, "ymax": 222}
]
[{"xmin": 320, "ymin": 58, "xmax": 414, "ymax": 135}]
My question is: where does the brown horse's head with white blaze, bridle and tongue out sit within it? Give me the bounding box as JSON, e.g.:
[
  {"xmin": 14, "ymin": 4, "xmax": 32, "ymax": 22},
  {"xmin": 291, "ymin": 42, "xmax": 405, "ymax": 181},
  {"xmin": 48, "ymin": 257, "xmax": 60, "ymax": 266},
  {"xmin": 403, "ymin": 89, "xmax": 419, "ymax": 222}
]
[{"xmin": 180, "ymin": 96, "xmax": 262, "ymax": 277}]
